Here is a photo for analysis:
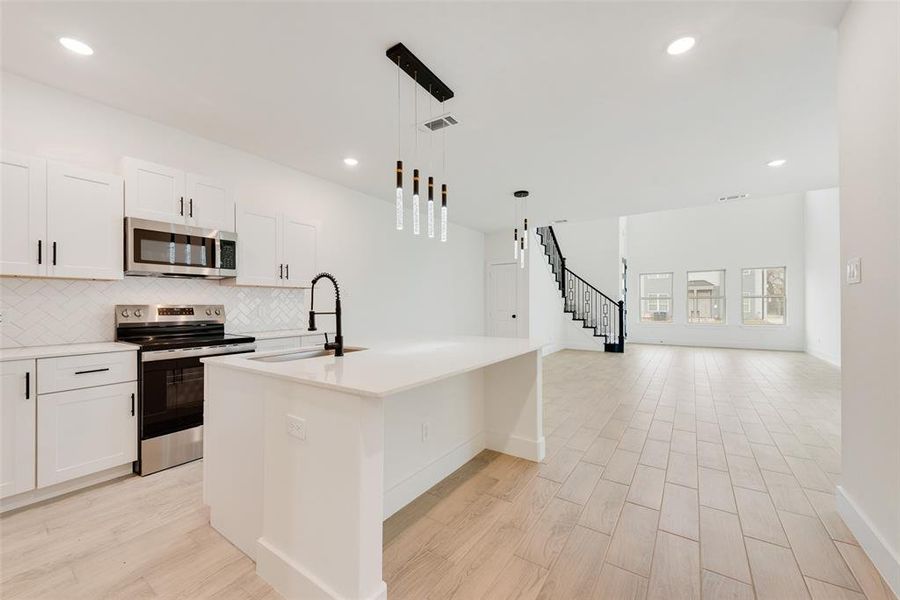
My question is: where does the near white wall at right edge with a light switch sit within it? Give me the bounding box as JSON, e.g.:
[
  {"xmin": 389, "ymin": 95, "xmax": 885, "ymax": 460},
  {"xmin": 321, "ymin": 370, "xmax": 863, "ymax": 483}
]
[{"xmin": 838, "ymin": 2, "xmax": 900, "ymax": 596}]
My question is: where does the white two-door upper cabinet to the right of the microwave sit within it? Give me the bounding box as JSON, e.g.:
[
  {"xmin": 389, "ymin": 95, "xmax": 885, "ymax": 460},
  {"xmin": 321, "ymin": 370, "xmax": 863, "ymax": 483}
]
[{"xmin": 234, "ymin": 205, "xmax": 316, "ymax": 288}]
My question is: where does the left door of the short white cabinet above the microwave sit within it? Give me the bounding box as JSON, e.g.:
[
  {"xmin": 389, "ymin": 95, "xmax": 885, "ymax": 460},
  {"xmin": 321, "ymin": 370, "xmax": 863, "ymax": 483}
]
[{"xmin": 122, "ymin": 158, "xmax": 187, "ymax": 223}]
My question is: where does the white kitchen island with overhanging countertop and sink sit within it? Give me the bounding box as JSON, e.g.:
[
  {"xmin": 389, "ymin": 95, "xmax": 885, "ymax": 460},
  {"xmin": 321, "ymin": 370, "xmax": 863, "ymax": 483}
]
[{"xmin": 203, "ymin": 337, "xmax": 544, "ymax": 600}]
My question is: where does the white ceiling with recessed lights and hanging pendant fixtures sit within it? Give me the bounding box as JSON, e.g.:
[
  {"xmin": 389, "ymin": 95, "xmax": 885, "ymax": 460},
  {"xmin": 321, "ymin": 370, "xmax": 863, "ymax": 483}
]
[{"xmin": 2, "ymin": 2, "xmax": 845, "ymax": 231}]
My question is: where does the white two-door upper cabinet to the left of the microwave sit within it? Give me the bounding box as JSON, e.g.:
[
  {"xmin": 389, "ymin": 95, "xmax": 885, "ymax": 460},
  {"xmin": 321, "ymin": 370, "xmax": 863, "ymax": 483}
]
[{"xmin": 0, "ymin": 152, "xmax": 124, "ymax": 279}]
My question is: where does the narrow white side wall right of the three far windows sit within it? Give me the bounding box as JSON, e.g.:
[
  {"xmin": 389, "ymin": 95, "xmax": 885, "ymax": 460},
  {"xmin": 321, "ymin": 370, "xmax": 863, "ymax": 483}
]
[{"xmin": 804, "ymin": 188, "xmax": 841, "ymax": 366}]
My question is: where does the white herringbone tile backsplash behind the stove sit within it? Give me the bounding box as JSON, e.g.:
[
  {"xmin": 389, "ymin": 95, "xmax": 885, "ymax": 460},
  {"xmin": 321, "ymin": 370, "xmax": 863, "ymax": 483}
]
[{"xmin": 0, "ymin": 277, "xmax": 306, "ymax": 348}]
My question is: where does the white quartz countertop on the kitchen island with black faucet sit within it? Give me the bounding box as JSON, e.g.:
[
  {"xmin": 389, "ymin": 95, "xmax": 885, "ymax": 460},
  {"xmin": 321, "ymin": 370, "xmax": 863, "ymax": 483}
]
[{"xmin": 201, "ymin": 336, "xmax": 543, "ymax": 398}]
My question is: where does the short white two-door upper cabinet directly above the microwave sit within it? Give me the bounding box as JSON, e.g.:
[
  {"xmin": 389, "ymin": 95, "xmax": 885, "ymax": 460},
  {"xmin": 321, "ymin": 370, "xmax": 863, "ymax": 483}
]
[{"xmin": 122, "ymin": 157, "xmax": 234, "ymax": 231}]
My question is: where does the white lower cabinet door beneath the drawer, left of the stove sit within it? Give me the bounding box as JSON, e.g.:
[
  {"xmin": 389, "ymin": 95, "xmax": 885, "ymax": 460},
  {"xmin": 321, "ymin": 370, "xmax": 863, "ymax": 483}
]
[{"xmin": 37, "ymin": 381, "xmax": 137, "ymax": 487}]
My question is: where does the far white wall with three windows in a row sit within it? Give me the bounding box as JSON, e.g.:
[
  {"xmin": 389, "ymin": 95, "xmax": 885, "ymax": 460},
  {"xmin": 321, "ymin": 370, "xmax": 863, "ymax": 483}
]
[{"xmin": 627, "ymin": 194, "xmax": 806, "ymax": 350}]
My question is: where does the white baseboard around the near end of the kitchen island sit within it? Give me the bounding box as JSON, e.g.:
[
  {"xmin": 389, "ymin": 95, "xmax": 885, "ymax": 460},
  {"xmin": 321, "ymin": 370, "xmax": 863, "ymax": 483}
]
[{"xmin": 256, "ymin": 538, "xmax": 387, "ymax": 600}]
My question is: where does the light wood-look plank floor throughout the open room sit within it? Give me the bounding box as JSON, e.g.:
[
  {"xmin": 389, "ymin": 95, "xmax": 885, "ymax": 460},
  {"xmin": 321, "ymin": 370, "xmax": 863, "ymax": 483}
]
[{"xmin": 0, "ymin": 345, "xmax": 894, "ymax": 600}]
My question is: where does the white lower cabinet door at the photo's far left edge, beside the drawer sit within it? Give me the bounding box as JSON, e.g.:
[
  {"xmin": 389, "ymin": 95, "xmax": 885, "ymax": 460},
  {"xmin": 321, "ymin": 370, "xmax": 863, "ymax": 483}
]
[{"xmin": 0, "ymin": 360, "xmax": 37, "ymax": 498}]
